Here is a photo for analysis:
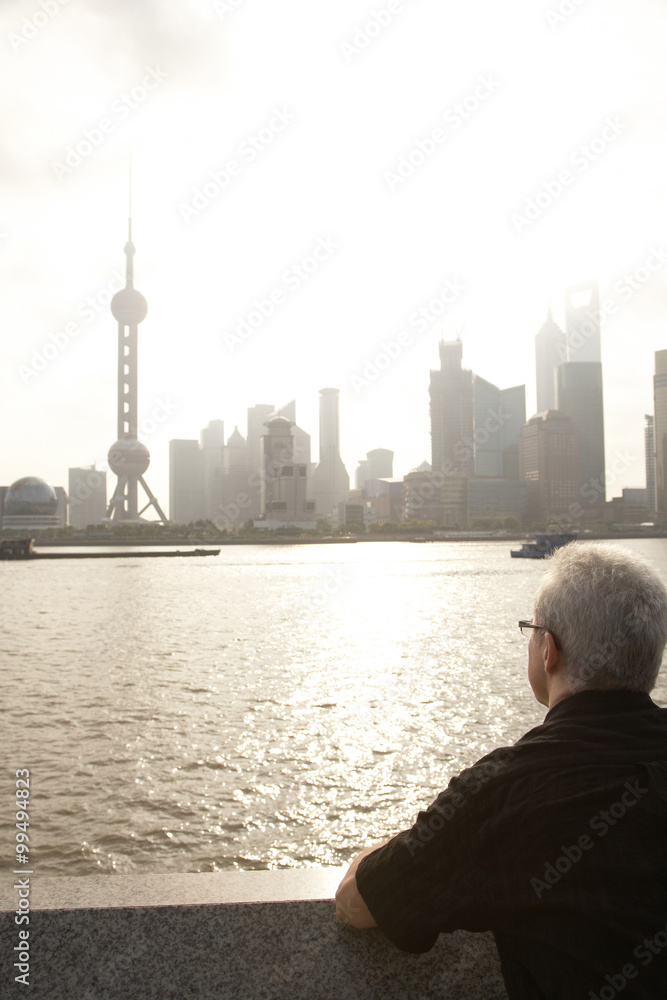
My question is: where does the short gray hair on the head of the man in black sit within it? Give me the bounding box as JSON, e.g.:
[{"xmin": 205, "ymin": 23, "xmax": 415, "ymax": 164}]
[{"xmin": 533, "ymin": 542, "xmax": 667, "ymax": 693}]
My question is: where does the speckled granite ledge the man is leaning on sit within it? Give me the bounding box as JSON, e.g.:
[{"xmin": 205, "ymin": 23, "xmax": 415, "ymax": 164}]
[{"xmin": 0, "ymin": 869, "xmax": 505, "ymax": 1000}]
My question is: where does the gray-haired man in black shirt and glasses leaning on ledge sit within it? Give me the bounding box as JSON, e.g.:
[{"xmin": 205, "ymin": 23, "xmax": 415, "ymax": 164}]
[{"xmin": 336, "ymin": 542, "xmax": 667, "ymax": 1000}]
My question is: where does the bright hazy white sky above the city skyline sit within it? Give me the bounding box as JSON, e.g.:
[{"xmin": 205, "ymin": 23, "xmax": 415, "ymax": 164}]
[{"xmin": 0, "ymin": 0, "xmax": 667, "ymax": 505}]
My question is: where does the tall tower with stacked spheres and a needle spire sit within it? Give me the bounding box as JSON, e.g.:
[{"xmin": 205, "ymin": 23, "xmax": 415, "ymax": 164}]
[{"xmin": 107, "ymin": 208, "xmax": 167, "ymax": 524}]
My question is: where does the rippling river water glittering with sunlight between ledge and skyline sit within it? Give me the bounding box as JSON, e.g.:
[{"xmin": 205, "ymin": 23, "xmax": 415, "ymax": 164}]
[{"xmin": 0, "ymin": 539, "xmax": 667, "ymax": 875}]
